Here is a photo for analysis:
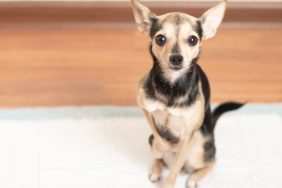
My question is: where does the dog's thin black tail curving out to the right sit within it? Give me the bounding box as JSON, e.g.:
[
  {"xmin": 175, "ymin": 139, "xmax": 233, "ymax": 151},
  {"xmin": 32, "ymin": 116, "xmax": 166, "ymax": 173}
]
[{"xmin": 212, "ymin": 102, "xmax": 246, "ymax": 130}]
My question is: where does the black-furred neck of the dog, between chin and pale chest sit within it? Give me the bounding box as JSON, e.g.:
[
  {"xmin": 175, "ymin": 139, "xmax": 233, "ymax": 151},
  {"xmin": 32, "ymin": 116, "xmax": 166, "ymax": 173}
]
[{"xmin": 144, "ymin": 56, "xmax": 200, "ymax": 107}]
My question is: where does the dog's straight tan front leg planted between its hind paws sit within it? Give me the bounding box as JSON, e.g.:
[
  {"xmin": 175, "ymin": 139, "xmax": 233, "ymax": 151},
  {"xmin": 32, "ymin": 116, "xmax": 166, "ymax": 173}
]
[{"xmin": 164, "ymin": 133, "xmax": 195, "ymax": 188}]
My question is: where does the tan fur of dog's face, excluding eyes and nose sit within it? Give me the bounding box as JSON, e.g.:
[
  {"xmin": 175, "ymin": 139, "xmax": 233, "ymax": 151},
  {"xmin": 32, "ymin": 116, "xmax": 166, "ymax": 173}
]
[{"xmin": 152, "ymin": 13, "xmax": 200, "ymax": 82}]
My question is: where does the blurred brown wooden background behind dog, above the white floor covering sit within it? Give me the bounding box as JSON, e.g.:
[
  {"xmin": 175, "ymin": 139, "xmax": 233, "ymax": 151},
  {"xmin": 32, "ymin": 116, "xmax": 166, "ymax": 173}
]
[{"xmin": 0, "ymin": 0, "xmax": 282, "ymax": 108}]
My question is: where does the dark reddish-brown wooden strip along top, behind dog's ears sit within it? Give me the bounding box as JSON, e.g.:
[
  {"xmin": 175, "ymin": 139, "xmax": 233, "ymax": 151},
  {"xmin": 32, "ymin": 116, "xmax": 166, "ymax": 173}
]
[{"xmin": 0, "ymin": 2, "xmax": 282, "ymax": 26}]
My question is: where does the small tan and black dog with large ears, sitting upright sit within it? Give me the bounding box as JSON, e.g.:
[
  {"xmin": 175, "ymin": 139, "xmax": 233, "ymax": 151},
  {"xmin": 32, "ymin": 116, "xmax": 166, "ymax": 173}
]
[{"xmin": 131, "ymin": 0, "xmax": 243, "ymax": 188}]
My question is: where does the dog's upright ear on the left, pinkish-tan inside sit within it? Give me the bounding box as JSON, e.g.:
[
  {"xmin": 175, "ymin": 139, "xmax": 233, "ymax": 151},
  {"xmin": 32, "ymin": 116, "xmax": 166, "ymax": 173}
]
[{"xmin": 131, "ymin": 0, "xmax": 156, "ymax": 33}]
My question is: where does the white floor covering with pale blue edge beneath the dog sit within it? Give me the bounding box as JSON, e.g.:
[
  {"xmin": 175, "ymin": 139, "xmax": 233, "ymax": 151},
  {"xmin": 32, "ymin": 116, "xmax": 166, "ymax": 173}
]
[{"xmin": 0, "ymin": 105, "xmax": 282, "ymax": 188}]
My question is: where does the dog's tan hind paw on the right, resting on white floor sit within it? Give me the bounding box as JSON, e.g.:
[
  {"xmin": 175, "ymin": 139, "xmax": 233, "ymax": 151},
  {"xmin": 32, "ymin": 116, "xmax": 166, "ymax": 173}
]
[{"xmin": 186, "ymin": 162, "xmax": 215, "ymax": 188}]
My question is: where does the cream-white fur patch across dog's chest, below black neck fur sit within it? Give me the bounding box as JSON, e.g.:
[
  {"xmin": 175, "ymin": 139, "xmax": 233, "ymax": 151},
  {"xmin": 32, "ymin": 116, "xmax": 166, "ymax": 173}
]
[{"xmin": 137, "ymin": 77, "xmax": 205, "ymax": 142}]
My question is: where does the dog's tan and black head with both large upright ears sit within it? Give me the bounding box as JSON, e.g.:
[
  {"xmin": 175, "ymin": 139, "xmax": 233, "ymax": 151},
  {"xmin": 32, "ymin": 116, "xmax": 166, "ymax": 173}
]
[{"xmin": 131, "ymin": 0, "xmax": 226, "ymax": 80}]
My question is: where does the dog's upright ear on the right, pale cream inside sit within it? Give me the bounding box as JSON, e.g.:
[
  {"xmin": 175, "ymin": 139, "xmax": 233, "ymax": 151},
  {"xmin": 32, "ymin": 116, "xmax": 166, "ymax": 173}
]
[{"xmin": 200, "ymin": 1, "xmax": 226, "ymax": 40}]
